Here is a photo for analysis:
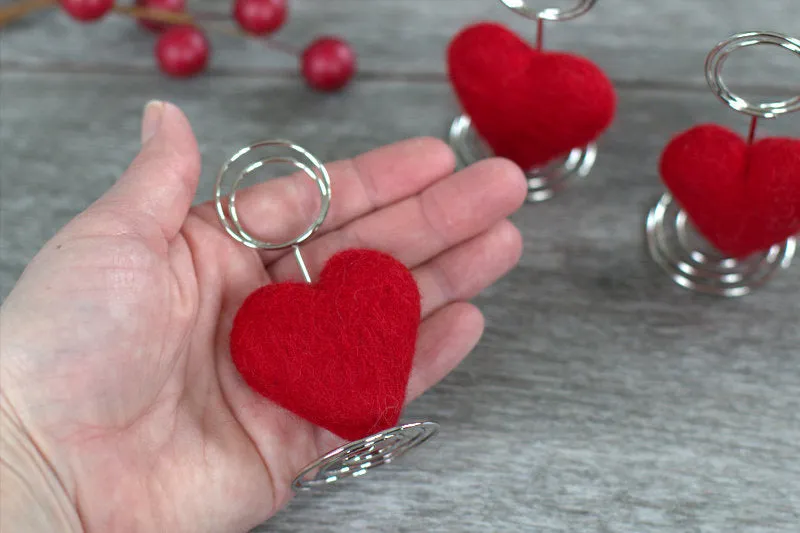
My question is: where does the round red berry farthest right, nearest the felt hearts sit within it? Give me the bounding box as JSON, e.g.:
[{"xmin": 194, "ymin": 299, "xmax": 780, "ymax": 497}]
[{"xmin": 301, "ymin": 37, "xmax": 356, "ymax": 91}]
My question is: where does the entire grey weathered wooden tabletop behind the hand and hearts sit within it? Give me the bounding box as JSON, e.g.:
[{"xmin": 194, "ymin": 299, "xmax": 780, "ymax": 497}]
[{"xmin": 0, "ymin": 0, "xmax": 800, "ymax": 533}]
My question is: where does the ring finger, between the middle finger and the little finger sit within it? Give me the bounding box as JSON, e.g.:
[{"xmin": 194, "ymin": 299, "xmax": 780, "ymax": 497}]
[{"xmin": 413, "ymin": 220, "xmax": 522, "ymax": 317}]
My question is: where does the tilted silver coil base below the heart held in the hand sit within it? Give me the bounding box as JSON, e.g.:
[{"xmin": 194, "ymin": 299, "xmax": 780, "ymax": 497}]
[{"xmin": 292, "ymin": 422, "xmax": 439, "ymax": 491}]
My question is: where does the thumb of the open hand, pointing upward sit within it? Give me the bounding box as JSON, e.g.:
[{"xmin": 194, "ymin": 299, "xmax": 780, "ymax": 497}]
[{"xmin": 96, "ymin": 101, "xmax": 200, "ymax": 240}]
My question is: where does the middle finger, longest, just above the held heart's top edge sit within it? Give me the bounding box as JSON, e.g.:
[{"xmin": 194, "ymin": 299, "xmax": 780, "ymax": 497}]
[{"xmin": 268, "ymin": 159, "xmax": 526, "ymax": 281}]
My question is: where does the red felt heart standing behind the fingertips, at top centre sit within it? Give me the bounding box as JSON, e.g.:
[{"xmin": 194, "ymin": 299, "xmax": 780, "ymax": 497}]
[{"xmin": 447, "ymin": 22, "xmax": 616, "ymax": 169}]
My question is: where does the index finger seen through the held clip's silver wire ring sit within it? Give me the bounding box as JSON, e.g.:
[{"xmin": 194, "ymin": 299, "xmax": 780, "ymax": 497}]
[{"xmin": 189, "ymin": 137, "xmax": 455, "ymax": 255}]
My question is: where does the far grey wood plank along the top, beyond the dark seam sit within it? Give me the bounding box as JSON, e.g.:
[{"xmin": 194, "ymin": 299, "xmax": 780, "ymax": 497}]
[{"xmin": 0, "ymin": 0, "xmax": 800, "ymax": 87}]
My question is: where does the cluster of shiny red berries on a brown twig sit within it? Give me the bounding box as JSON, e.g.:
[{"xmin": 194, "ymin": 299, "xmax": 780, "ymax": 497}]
[{"xmin": 58, "ymin": 0, "xmax": 356, "ymax": 91}]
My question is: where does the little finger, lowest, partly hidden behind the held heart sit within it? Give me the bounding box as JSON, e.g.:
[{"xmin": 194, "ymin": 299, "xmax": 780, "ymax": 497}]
[{"xmin": 406, "ymin": 302, "xmax": 484, "ymax": 403}]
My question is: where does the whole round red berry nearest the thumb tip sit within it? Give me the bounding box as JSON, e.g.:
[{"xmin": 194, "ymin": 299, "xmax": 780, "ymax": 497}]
[{"xmin": 156, "ymin": 26, "xmax": 210, "ymax": 78}]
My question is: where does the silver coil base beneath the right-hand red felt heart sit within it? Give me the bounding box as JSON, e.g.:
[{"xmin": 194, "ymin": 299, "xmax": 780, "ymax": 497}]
[{"xmin": 646, "ymin": 193, "xmax": 797, "ymax": 297}]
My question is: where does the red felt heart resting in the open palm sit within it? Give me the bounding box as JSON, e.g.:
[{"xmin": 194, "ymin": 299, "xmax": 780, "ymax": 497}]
[{"xmin": 231, "ymin": 250, "xmax": 421, "ymax": 440}]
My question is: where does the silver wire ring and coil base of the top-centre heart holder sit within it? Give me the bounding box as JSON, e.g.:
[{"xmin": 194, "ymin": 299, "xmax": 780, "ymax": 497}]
[{"xmin": 448, "ymin": 0, "xmax": 597, "ymax": 202}]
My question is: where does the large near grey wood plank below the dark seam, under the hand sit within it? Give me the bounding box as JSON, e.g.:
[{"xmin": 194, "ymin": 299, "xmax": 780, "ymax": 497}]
[{"xmin": 0, "ymin": 73, "xmax": 800, "ymax": 533}]
